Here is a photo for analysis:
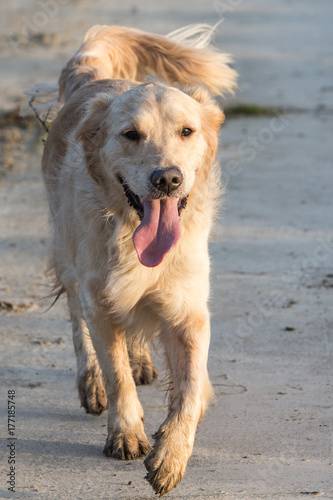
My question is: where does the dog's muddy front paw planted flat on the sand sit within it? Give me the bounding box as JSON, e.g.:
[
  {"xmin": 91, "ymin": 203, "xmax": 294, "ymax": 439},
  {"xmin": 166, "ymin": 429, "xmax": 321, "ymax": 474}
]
[{"xmin": 103, "ymin": 431, "xmax": 152, "ymax": 460}]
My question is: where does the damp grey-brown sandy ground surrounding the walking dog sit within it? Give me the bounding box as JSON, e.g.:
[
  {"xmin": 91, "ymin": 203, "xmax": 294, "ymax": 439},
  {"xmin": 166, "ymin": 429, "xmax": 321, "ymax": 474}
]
[{"xmin": 0, "ymin": 0, "xmax": 333, "ymax": 500}]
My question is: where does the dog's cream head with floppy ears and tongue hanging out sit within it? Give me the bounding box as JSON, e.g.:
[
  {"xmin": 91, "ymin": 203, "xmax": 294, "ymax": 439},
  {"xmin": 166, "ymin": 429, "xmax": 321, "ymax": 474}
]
[{"xmin": 78, "ymin": 83, "xmax": 224, "ymax": 267}]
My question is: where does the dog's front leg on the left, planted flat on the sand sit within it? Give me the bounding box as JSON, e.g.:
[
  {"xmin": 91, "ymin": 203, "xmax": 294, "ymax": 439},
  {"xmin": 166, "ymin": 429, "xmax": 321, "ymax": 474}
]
[{"xmin": 81, "ymin": 288, "xmax": 151, "ymax": 460}]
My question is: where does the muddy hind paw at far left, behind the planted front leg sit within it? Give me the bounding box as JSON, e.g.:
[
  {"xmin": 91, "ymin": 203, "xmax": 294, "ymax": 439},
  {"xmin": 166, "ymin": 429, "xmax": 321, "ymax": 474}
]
[{"xmin": 78, "ymin": 367, "xmax": 108, "ymax": 416}]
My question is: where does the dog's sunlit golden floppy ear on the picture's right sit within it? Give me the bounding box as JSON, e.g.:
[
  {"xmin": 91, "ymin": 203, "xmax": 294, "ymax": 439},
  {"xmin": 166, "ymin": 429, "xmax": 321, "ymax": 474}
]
[{"xmin": 184, "ymin": 86, "xmax": 225, "ymax": 177}]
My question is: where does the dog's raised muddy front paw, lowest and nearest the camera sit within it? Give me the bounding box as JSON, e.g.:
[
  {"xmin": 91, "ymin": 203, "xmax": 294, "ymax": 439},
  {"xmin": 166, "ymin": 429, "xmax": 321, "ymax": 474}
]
[{"xmin": 144, "ymin": 446, "xmax": 187, "ymax": 497}]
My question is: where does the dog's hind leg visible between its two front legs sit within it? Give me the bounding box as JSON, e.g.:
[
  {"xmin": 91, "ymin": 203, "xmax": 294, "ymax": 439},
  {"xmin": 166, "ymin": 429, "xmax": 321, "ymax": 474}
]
[{"xmin": 127, "ymin": 337, "xmax": 157, "ymax": 385}]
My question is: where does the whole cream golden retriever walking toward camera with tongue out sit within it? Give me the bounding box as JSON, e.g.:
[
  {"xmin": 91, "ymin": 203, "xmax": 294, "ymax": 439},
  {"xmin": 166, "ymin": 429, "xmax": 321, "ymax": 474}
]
[{"xmin": 42, "ymin": 25, "xmax": 236, "ymax": 495}]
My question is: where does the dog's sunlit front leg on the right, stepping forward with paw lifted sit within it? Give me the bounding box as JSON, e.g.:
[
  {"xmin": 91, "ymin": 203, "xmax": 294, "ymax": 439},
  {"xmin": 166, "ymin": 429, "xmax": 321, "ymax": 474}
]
[{"xmin": 145, "ymin": 312, "xmax": 213, "ymax": 496}]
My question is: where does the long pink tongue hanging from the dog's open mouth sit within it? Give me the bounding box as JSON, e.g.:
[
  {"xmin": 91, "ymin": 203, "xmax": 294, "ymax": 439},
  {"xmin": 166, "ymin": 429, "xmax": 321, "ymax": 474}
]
[{"xmin": 133, "ymin": 197, "xmax": 180, "ymax": 267}]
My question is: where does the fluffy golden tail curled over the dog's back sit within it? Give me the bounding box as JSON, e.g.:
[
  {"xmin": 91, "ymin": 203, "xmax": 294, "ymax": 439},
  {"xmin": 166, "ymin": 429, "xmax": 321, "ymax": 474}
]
[{"xmin": 59, "ymin": 24, "xmax": 237, "ymax": 102}]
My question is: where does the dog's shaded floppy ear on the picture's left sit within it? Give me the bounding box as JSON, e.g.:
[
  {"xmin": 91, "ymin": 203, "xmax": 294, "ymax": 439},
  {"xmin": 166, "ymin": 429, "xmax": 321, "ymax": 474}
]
[{"xmin": 76, "ymin": 93, "xmax": 112, "ymax": 182}]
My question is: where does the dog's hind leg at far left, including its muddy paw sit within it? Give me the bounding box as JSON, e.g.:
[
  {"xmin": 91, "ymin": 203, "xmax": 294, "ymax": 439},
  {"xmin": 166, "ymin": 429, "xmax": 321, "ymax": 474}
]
[{"xmin": 67, "ymin": 287, "xmax": 108, "ymax": 415}]
